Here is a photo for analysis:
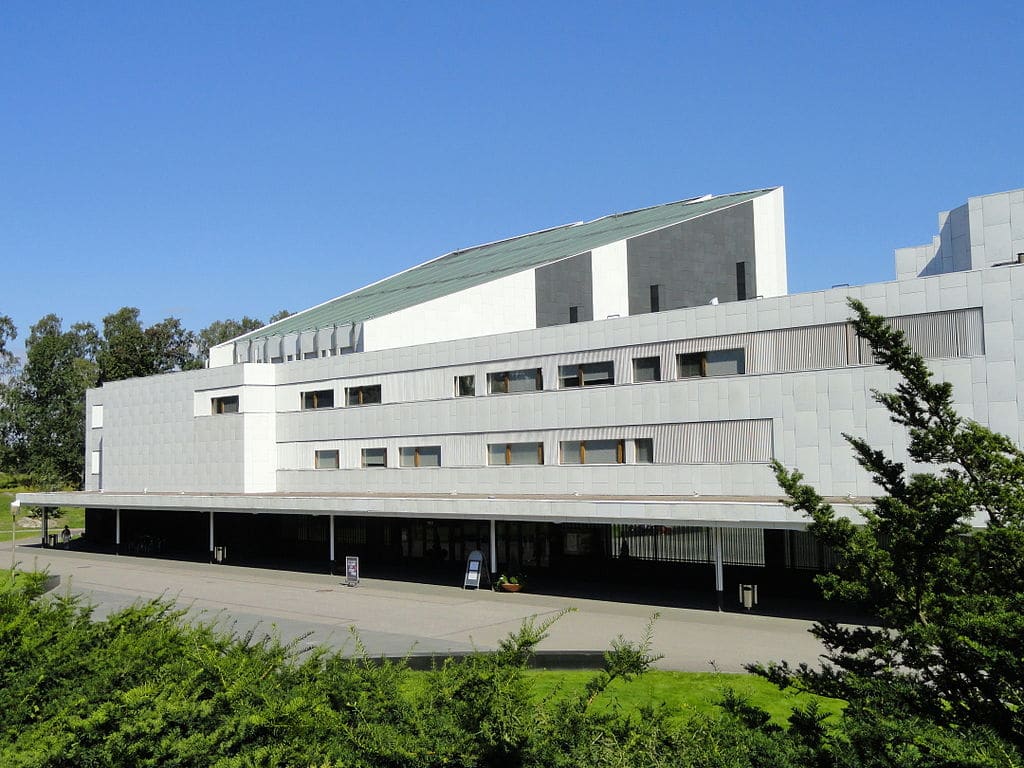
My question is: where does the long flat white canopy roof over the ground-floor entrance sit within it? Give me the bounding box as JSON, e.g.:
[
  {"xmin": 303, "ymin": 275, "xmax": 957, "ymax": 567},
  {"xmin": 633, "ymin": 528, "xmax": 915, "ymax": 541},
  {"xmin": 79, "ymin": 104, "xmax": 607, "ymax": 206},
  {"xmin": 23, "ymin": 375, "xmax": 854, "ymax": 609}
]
[{"xmin": 17, "ymin": 490, "xmax": 871, "ymax": 530}]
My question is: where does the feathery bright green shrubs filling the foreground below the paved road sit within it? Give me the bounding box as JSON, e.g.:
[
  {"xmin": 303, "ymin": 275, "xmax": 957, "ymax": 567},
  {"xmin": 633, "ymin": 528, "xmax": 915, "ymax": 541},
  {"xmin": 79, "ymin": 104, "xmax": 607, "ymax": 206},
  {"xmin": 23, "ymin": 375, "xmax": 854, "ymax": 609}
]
[{"xmin": 0, "ymin": 573, "xmax": 815, "ymax": 768}]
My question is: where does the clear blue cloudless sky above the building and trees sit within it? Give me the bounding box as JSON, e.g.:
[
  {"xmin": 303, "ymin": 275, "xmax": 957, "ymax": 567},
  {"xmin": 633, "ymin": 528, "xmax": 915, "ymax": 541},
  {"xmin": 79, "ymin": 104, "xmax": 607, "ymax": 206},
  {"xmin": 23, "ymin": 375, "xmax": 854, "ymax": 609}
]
[{"xmin": 0, "ymin": 0, "xmax": 1024, "ymax": 352}]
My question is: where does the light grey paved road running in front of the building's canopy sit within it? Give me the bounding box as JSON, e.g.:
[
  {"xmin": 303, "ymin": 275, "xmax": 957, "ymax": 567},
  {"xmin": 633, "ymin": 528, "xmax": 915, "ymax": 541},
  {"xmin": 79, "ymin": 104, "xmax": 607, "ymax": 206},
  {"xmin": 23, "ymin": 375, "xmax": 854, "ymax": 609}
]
[{"xmin": 8, "ymin": 545, "xmax": 821, "ymax": 672}]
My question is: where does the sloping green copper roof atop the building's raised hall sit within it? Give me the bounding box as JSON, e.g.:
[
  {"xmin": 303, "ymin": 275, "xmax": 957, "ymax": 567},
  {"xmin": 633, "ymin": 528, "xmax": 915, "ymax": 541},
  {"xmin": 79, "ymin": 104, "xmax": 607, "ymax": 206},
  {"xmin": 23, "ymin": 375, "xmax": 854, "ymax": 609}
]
[{"xmin": 239, "ymin": 189, "xmax": 771, "ymax": 339}]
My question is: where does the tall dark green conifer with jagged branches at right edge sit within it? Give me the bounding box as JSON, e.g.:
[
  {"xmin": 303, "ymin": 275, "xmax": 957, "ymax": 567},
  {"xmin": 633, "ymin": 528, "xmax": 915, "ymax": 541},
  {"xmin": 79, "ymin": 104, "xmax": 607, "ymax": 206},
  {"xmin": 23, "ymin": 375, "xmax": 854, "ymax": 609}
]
[{"xmin": 758, "ymin": 300, "xmax": 1024, "ymax": 765}]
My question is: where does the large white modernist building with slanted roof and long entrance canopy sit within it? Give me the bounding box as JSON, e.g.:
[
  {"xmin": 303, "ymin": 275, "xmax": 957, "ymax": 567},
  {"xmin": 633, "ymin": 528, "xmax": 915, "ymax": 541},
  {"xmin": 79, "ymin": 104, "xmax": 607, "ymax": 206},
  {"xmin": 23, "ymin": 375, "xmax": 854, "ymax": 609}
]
[{"xmin": 19, "ymin": 188, "xmax": 1024, "ymax": 606}]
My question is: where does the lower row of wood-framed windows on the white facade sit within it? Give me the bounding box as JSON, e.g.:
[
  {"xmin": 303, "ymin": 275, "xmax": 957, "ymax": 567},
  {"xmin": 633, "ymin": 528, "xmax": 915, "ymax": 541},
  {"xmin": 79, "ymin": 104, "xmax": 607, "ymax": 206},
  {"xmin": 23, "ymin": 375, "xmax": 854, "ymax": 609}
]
[{"xmin": 313, "ymin": 437, "xmax": 654, "ymax": 469}]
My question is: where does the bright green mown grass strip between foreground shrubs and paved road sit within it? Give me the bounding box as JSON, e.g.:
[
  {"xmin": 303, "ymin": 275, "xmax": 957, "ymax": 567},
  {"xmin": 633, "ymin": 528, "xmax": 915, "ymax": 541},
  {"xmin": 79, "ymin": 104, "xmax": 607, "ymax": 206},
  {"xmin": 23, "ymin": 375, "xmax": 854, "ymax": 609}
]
[{"xmin": 527, "ymin": 670, "xmax": 843, "ymax": 725}]
